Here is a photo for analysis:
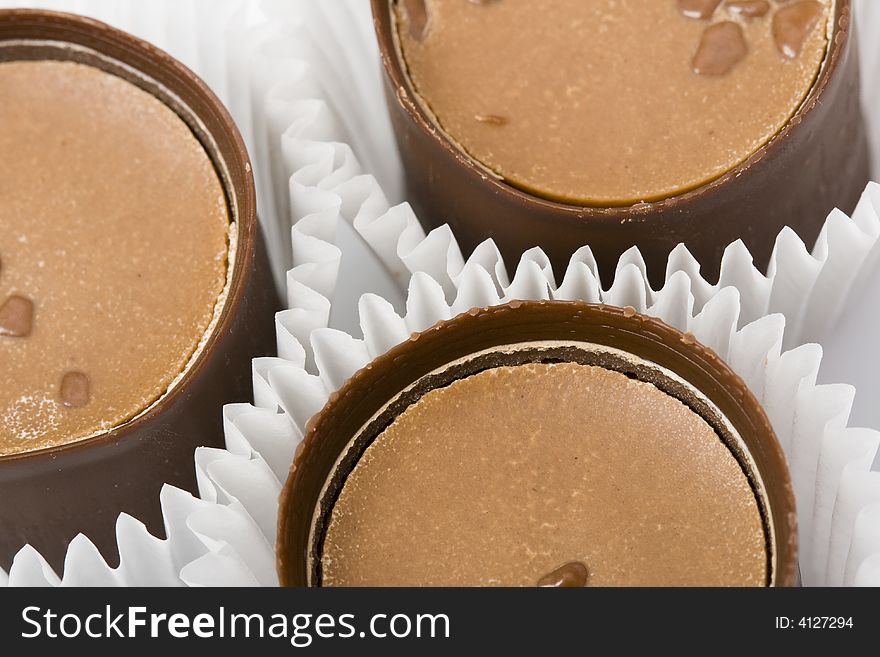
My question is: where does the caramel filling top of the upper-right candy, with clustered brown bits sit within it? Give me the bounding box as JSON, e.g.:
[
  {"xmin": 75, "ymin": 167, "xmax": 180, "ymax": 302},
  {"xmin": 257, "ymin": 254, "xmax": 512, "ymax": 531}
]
[{"xmin": 395, "ymin": 0, "xmax": 833, "ymax": 206}]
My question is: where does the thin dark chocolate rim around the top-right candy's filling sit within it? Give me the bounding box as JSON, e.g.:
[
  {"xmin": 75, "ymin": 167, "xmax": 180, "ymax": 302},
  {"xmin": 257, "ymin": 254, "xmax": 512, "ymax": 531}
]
[{"xmin": 370, "ymin": 0, "xmax": 852, "ymax": 211}]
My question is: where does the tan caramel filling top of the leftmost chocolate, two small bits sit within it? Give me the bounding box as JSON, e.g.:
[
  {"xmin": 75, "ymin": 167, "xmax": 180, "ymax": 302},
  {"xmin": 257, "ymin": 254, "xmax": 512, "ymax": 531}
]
[{"xmin": 0, "ymin": 61, "xmax": 230, "ymax": 455}]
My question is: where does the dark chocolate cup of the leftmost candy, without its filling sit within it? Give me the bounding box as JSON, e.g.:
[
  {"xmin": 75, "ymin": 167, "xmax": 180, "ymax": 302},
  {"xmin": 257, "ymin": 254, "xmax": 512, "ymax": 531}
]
[{"xmin": 0, "ymin": 10, "xmax": 280, "ymax": 572}]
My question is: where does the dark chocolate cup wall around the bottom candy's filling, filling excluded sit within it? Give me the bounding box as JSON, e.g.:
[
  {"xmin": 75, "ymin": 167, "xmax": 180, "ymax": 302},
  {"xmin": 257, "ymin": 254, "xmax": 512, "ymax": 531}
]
[{"xmin": 276, "ymin": 301, "xmax": 798, "ymax": 586}]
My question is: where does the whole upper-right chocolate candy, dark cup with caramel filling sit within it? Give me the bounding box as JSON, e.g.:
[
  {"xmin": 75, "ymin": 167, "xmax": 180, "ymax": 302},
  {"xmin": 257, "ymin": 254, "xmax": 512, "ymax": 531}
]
[{"xmin": 373, "ymin": 0, "xmax": 869, "ymax": 286}]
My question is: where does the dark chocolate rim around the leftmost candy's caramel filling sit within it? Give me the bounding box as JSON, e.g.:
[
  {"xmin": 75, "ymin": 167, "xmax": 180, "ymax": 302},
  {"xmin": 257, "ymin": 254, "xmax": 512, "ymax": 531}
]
[{"xmin": 0, "ymin": 9, "xmax": 257, "ymax": 465}]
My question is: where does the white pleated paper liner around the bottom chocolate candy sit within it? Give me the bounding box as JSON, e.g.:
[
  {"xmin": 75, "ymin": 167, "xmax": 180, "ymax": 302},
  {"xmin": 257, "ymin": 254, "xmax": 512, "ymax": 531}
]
[{"xmin": 10, "ymin": 243, "xmax": 880, "ymax": 585}]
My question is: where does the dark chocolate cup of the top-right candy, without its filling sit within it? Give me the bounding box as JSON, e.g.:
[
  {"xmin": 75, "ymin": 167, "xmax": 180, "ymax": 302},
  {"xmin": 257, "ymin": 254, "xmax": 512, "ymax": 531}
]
[{"xmin": 372, "ymin": 0, "xmax": 869, "ymax": 287}]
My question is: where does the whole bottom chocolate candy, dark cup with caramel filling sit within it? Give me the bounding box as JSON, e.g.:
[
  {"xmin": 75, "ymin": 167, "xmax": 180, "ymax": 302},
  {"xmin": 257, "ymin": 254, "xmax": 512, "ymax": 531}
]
[{"xmin": 277, "ymin": 301, "xmax": 797, "ymax": 586}]
